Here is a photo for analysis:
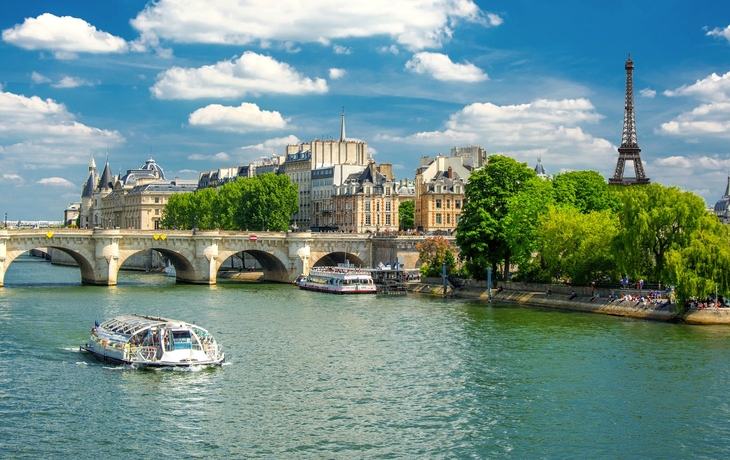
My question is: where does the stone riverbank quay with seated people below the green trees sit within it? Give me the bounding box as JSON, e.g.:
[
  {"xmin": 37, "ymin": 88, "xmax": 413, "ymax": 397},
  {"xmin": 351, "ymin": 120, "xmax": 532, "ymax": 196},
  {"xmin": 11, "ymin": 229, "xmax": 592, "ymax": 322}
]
[{"xmin": 408, "ymin": 278, "xmax": 730, "ymax": 325}]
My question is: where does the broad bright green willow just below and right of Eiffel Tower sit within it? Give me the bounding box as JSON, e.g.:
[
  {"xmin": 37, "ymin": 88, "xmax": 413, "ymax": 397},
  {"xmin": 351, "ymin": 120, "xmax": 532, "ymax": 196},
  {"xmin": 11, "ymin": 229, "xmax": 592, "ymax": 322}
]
[{"xmin": 614, "ymin": 183, "xmax": 707, "ymax": 282}]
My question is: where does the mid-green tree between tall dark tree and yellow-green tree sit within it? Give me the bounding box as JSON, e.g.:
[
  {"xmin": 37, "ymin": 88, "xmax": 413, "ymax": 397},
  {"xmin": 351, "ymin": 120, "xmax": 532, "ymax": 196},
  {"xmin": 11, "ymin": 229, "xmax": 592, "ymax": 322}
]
[{"xmin": 504, "ymin": 177, "xmax": 553, "ymax": 271}]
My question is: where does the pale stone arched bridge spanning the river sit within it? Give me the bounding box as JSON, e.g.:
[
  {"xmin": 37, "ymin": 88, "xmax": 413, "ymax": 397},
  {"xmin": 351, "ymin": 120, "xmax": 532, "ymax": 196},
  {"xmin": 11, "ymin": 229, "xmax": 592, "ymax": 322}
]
[{"xmin": 0, "ymin": 229, "xmax": 432, "ymax": 287}]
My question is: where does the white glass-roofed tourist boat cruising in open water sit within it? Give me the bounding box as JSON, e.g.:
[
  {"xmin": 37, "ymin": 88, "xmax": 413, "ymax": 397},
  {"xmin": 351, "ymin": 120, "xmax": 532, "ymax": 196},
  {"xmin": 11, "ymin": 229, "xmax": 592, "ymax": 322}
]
[{"xmin": 81, "ymin": 314, "xmax": 225, "ymax": 367}]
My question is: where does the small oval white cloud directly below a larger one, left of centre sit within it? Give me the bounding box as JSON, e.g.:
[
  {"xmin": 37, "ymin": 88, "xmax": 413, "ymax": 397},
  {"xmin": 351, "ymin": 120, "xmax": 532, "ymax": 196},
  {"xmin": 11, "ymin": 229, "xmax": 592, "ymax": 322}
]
[{"xmin": 188, "ymin": 102, "xmax": 286, "ymax": 133}]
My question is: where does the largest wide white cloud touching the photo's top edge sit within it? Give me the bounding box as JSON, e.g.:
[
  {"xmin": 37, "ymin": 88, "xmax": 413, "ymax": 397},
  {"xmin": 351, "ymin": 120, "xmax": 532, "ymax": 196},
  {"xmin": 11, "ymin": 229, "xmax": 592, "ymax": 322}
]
[{"xmin": 131, "ymin": 0, "xmax": 502, "ymax": 51}]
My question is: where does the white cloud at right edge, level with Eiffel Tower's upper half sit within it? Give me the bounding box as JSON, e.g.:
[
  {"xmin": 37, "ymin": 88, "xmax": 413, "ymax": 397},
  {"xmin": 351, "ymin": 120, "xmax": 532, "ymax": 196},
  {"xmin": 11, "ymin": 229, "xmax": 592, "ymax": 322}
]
[{"xmin": 658, "ymin": 72, "xmax": 730, "ymax": 138}]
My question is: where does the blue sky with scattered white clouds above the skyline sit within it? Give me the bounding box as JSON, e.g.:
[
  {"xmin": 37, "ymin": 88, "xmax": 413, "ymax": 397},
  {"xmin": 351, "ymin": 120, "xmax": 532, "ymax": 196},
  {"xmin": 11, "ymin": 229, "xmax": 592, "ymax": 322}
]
[{"xmin": 0, "ymin": 0, "xmax": 730, "ymax": 221}]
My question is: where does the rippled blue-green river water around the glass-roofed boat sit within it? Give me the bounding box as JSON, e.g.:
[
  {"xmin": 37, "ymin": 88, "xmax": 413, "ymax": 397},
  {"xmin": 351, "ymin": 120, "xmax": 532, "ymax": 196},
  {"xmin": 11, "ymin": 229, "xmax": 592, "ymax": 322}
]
[{"xmin": 0, "ymin": 253, "xmax": 730, "ymax": 458}]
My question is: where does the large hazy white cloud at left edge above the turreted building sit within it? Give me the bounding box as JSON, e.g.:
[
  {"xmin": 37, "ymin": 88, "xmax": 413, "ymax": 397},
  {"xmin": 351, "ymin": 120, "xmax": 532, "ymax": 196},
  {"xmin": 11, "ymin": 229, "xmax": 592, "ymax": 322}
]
[{"xmin": 0, "ymin": 92, "xmax": 124, "ymax": 167}]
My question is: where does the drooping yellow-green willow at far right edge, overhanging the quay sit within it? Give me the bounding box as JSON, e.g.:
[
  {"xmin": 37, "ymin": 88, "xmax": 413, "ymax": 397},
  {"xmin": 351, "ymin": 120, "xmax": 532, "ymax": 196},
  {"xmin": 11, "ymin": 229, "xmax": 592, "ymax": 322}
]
[{"xmin": 666, "ymin": 214, "xmax": 730, "ymax": 309}]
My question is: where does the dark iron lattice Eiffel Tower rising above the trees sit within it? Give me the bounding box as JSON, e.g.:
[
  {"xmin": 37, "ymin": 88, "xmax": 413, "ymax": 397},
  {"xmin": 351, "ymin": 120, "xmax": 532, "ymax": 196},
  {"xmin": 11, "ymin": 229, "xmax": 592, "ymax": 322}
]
[{"xmin": 608, "ymin": 54, "xmax": 650, "ymax": 185}]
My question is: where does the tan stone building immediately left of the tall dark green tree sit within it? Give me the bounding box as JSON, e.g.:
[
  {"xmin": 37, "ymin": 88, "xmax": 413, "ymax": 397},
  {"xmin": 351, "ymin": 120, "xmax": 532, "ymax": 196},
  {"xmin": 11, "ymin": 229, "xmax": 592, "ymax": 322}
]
[{"xmin": 414, "ymin": 155, "xmax": 472, "ymax": 232}]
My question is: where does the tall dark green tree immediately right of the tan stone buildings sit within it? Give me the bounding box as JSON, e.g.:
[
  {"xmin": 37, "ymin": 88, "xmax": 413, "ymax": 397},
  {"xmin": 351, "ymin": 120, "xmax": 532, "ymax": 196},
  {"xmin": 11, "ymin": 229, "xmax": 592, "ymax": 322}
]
[{"xmin": 456, "ymin": 155, "xmax": 536, "ymax": 279}]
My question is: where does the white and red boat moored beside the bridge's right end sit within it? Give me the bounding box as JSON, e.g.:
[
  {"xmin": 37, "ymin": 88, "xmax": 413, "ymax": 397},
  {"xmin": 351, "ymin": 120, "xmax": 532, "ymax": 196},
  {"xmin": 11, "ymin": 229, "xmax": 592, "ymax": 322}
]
[{"xmin": 299, "ymin": 266, "xmax": 377, "ymax": 294}]
